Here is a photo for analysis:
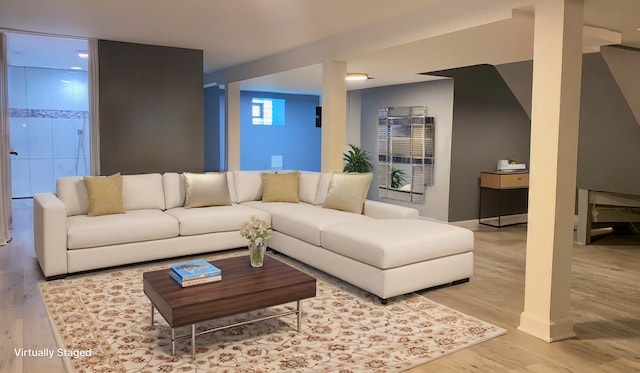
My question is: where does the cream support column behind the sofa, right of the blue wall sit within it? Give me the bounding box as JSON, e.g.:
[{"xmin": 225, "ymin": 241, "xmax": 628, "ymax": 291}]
[{"xmin": 321, "ymin": 61, "xmax": 347, "ymax": 172}]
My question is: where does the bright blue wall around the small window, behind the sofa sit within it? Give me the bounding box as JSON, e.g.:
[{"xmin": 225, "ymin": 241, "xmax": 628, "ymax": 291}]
[{"xmin": 240, "ymin": 91, "xmax": 321, "ymax": 171}]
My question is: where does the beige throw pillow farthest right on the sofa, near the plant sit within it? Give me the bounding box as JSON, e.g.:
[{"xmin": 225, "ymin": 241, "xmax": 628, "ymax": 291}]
[{"xmin": 322, "ymin": 173, "xmax": 373, "ymax": 214}]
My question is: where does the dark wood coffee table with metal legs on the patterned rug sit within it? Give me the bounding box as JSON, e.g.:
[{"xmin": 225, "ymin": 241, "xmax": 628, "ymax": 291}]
[{"xmin": 142, "ymin": 256, "xmax": 316, "ymax": 359}]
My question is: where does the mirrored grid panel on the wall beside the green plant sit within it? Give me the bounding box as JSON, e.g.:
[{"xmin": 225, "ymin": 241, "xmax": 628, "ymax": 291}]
[{"xmin": 378, "ymin": 106, "xmax": 434, "ymax": 203}]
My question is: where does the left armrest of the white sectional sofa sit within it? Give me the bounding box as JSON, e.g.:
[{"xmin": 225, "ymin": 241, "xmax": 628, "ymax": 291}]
[{"xmin": 33, "ymin": 193, "xmax": 67, "ymax": 278}]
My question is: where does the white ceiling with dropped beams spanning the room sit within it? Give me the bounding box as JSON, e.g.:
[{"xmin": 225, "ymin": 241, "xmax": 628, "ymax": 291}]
[{"xmin": 0, "ymin": 0, "xmax": 640, "ymax": 94}]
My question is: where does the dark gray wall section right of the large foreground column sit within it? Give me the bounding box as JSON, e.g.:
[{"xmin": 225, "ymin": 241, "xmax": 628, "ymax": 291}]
[{"xmin": 577, "ymin": 53, "xmax": 640, "ymax": 194}]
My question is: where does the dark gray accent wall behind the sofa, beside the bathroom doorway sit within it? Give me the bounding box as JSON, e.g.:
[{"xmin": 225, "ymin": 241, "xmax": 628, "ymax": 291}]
[{"xmin": 98, "ymin": 40, "xmax": 204, "ymax": 175}]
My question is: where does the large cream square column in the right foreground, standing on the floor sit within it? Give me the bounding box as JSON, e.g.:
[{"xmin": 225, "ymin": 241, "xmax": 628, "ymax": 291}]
[{"xmin": 518, "ymin": 0, "xmax": 584, "ymax": 342}]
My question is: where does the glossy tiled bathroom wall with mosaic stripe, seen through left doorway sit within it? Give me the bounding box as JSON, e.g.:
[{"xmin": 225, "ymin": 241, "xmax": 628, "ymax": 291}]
[{"xmin": 8, "ymin": 66, "xmax": 89, "ymax": 198}]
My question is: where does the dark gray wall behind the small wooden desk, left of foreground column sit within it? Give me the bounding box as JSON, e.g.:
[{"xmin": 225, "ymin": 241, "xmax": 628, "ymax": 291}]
[{"xmin": 428, "ymin": 65, "xmax": 531, "ymax": 221}]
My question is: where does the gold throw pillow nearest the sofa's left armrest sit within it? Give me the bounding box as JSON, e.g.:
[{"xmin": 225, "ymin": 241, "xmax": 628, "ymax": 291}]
[{"xmin": 84, "ymin": 172, "xmax": 124, "ymax": 216}]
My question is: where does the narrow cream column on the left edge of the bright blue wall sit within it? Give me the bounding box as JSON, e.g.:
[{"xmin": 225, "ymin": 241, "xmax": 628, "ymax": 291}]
[{"xmin": 225, "ymin": 82, "xmax": 240, "ymax": 171}]
